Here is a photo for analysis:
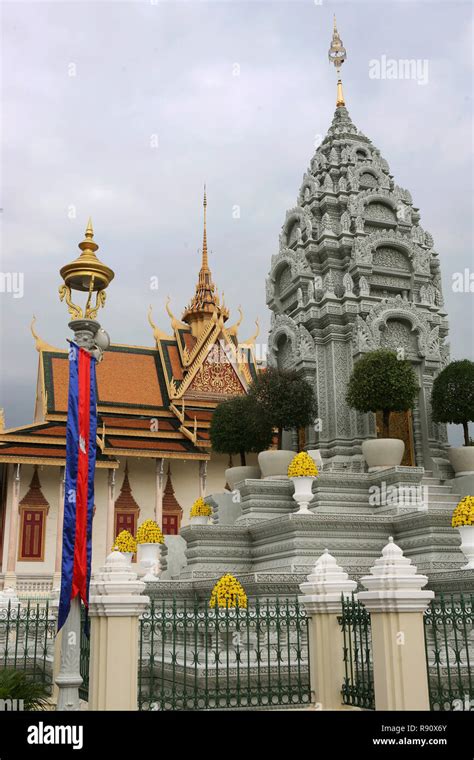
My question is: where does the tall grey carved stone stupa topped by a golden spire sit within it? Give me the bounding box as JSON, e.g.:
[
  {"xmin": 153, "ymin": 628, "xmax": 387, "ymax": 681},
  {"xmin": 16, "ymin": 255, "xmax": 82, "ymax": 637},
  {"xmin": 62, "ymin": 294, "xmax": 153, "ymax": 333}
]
[{"xmin": 266, "ymin": 17, "xmax": 450, "ymax": 474}]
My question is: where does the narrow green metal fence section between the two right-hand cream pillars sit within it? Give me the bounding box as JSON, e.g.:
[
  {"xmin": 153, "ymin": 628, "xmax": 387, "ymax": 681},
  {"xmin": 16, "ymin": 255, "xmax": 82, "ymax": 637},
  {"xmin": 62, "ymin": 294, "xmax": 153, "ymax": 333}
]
[{"xmin": 339, "ymin": 595, "xmax": 375, "ymax": 710}]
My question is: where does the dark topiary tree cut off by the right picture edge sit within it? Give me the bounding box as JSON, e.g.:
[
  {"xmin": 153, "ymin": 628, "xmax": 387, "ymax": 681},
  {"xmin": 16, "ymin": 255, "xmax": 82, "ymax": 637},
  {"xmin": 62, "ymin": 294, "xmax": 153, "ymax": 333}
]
[{"xmin": 431, "ymin": 359, "xmax": 474, "ymax": 446}]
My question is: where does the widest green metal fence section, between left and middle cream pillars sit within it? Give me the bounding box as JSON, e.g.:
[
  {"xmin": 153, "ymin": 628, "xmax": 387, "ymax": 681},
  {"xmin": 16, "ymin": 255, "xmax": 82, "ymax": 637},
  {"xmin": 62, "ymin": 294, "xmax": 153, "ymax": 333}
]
[{"xmin": 138, "ymin": 600, "xmax": 311, "ymax": 710}]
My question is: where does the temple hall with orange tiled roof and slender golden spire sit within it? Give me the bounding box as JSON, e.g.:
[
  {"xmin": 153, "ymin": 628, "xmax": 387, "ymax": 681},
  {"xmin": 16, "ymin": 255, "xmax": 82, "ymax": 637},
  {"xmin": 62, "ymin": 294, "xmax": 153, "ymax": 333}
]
[{"xmin": 0, "ymin": 192, "xmax": 258, "ymax": 592}]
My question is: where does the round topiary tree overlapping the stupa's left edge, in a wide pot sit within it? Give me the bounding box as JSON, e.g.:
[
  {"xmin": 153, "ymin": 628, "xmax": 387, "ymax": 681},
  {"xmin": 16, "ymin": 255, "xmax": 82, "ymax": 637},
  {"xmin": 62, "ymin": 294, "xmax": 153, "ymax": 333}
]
[{"xmin": 249, "ymin": 367, "xmax": 318, "ymax": 449}]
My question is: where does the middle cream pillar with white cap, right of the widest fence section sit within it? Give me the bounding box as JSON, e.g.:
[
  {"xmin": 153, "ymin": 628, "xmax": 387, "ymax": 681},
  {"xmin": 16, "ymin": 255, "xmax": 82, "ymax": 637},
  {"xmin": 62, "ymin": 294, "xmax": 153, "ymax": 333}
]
[{"xmin": 299, "ymin": 549, "xmax": 357, "ymax": 710}]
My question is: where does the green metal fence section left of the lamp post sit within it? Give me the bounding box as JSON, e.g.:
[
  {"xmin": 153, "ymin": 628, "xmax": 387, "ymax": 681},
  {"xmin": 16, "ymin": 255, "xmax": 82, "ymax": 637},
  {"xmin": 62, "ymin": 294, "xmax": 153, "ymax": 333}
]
[{"xmin": 0, "ymin": 601, "xmax": 56, "ymax": 690}]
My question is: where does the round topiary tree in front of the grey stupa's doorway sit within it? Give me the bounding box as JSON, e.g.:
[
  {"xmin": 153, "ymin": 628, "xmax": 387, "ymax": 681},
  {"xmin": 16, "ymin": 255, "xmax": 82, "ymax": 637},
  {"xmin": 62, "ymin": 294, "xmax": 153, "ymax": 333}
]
[{"xmin": 346, "ymin": 348, "xmax": 420, "ymax": 438}]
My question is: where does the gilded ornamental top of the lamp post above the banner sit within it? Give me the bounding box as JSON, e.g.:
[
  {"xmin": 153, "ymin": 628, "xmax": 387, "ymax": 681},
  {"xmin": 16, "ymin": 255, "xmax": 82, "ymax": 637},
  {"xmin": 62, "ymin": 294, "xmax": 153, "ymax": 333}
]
[{"xmin": 59, "ymin": 219, "xmax": 115, "ymax": 319}]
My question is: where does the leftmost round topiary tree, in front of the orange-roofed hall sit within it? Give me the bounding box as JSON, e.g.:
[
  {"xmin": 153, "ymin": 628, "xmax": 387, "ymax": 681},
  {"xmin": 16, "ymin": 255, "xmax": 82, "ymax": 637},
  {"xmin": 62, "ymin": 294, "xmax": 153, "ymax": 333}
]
[{"xmin": 210, "ymin": 396, "xmax": 273, "ymax": 467}]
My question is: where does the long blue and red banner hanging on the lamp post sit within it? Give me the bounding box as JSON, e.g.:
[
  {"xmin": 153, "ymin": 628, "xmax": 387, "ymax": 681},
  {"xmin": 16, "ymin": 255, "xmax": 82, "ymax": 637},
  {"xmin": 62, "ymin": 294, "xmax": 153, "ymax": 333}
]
[{"xmin": 58, "ymin": 342, "xmax": 97, "ymax": 631}]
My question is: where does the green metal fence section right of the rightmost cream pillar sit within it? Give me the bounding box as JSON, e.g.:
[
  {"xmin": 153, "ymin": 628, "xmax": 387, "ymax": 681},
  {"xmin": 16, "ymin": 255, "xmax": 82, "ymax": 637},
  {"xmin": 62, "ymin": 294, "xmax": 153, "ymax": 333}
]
[{"xmin": 424, "ymin": 594, "xmax": 474, "ymax": 711}]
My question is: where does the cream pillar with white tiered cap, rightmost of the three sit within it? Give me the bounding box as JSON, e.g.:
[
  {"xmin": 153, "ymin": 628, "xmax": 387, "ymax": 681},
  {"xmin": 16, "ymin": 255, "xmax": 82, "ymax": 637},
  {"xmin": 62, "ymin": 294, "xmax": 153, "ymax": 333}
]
[{"xmin": 358, "ymin": 537, "xmax": 434, "ymax": 710}]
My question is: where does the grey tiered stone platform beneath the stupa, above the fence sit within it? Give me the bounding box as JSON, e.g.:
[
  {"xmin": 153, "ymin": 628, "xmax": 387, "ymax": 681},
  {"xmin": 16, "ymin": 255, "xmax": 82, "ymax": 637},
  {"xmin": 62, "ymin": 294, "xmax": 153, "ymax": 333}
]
[{"xmin": 153, "ymin": 467, "xmax": 474, "ymax": 596}]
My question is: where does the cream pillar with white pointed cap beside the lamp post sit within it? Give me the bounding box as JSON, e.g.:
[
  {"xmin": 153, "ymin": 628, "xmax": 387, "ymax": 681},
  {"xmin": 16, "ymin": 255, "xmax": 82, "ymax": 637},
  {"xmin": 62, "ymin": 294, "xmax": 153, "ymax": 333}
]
[{"xmin": 89, "ymin": 552, "xmax": 150, "ymax": 710}]
